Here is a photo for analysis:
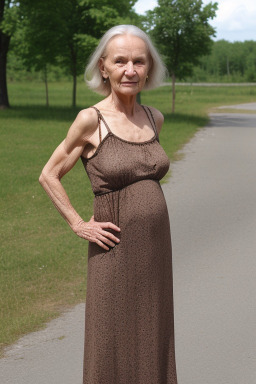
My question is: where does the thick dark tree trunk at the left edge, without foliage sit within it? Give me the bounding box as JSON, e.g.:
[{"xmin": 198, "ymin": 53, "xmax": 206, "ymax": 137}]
[{"xmin": 0, "ymin": 31, "xmax": 11, "ymax": 109}]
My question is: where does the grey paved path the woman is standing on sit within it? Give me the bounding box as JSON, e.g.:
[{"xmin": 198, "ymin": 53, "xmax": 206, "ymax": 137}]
[{"xmin": 0, "ymin": 105, "xmax": 256, "ymax": 384}]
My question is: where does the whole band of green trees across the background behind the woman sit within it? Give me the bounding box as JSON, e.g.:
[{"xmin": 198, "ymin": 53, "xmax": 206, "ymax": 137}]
[{"xmin": 0, "ymin": 0, "xmax": 256, "ymax": 111}]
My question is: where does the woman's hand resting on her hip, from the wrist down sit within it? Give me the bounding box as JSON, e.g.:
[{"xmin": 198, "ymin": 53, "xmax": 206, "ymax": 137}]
[{"xmin": 73, "ymin": 216, "xmax": 121, "ymax": 251}]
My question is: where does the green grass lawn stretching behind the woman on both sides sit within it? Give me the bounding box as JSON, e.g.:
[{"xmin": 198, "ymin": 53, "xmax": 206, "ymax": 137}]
[{"xmin": 0, "ymin": 83, "xmax": 256, "ymax": 354}]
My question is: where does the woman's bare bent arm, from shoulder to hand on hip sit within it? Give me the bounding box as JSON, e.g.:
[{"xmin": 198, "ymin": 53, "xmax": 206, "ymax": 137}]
[{"xmin": 39, "ymin": 109, "xmax": 120, "ymax": 250}]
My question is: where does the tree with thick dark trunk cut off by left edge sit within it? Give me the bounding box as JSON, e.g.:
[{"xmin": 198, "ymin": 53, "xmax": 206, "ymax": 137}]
[{"xmin": 0, "ymin": 0, "xmax": 17, "ymax": 109}]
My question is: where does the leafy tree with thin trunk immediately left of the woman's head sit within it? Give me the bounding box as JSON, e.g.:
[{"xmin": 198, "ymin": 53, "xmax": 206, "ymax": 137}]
[{"xmin": 55, "ymin": 0, "xmax": 140, "ymax": 106}]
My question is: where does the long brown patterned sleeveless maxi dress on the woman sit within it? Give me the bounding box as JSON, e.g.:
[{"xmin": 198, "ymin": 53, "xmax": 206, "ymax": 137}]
[{"xmin": 82, "ymin": 107, "xmax": 177, "ymax": 384}]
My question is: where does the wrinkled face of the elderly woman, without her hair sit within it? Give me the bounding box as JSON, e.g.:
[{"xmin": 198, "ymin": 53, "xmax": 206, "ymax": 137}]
[{"xmin": 100, "ymin": 35, "xmax": 150, "ymax": 96}]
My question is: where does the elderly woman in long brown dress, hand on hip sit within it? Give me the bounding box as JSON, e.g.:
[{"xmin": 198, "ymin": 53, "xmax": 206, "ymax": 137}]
[{"xmin": 40, "ymin": 25, "xmax": 177, "ymax": 384}]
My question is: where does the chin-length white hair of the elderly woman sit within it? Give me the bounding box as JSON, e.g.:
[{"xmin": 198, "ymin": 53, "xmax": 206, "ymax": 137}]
[{"xmin": 84, "ymin": 25, "xmax": 167, "ymax": 96}]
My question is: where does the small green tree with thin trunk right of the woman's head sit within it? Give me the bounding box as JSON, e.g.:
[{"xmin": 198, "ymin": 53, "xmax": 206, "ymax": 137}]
[{"xmin": 145, "ymin": 0, "xmax": 217, "ymax": 113}]
